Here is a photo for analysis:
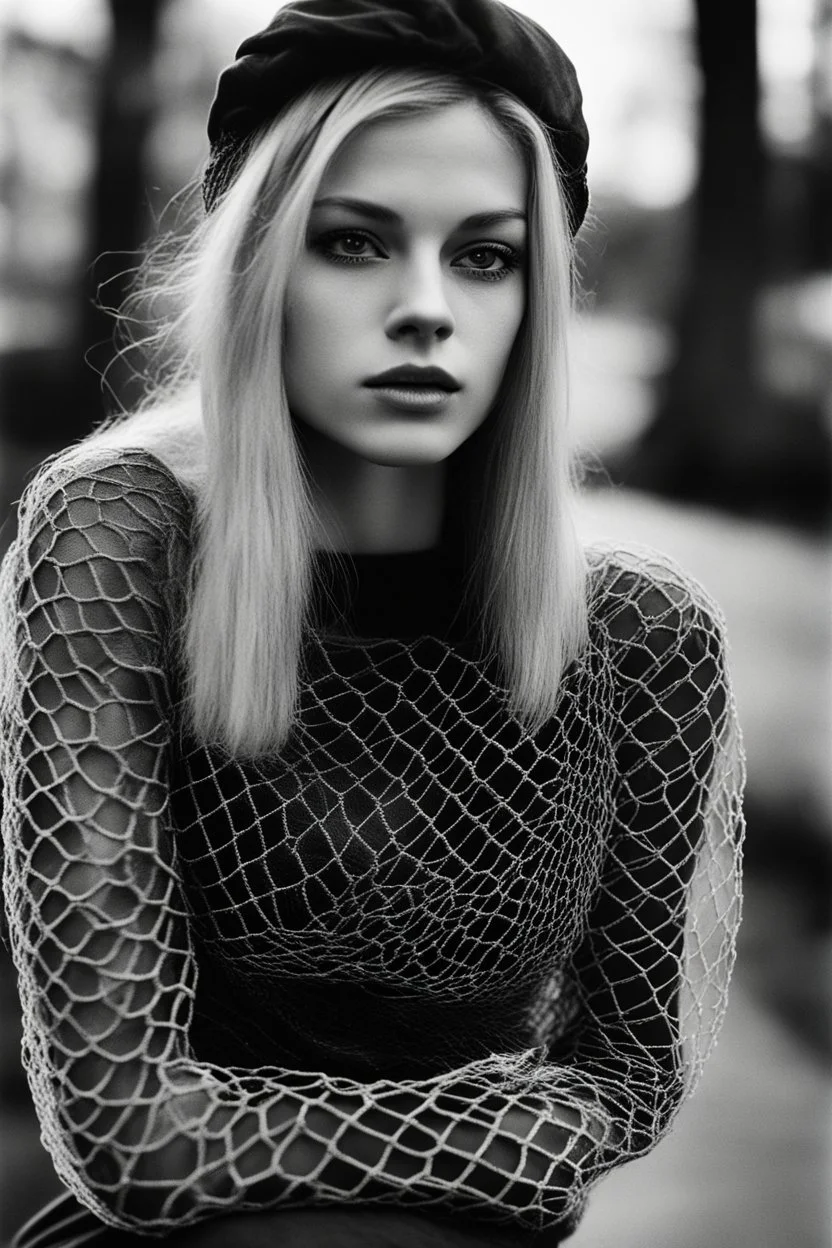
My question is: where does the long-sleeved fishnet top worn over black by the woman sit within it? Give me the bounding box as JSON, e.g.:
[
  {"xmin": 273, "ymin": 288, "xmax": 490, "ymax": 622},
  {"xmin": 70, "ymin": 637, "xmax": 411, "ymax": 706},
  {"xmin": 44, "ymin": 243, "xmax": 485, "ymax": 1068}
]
[{"xmin": 0, "ymin": 451, "xmax": 742, "ymax": 1234}]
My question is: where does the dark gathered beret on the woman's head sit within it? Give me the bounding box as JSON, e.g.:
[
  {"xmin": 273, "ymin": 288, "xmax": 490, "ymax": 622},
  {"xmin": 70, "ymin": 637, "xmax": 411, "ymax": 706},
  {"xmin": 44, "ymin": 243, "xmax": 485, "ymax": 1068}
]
[{"xmin": 203, "ymin": 0, "xmax": 589, "ymax": 232}]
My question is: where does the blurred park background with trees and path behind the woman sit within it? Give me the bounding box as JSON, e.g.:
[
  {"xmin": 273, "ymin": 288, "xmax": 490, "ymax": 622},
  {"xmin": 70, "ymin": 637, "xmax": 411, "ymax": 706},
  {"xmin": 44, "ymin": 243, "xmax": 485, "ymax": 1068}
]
[{"xmin": 0, "ymin": 0, "xmax": 832, "ymax": 1248}]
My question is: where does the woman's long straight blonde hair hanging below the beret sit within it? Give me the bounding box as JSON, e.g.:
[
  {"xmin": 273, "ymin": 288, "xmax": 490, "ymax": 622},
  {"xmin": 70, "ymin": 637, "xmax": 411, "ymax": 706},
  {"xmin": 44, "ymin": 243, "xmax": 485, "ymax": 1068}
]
[{"xmin": 76, "ymin": 70, "xmax": 586, "ymax": 756}]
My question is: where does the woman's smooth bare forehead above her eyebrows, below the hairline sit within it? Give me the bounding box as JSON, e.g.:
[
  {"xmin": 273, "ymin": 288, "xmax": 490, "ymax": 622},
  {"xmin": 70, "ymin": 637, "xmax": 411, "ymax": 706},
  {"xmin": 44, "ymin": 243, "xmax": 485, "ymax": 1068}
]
[{"xmin": 319, "ymin": 101, "xmax": 526, "ymax": 216}]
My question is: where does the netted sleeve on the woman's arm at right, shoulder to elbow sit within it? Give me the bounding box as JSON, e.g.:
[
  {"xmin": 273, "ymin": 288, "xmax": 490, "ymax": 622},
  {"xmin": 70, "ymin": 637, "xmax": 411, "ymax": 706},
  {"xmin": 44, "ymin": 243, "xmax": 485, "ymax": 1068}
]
[{"xmin": 543, "ymin": 552, "xmax": 745, "ymax": 1164}]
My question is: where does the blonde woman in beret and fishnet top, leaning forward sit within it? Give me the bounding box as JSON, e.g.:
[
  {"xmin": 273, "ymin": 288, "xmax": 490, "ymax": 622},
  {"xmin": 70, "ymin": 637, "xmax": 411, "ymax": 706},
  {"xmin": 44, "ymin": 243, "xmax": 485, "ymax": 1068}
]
[{"xmin": 2, "ymin": 0, "xmax": 741, "ymax": 1248}]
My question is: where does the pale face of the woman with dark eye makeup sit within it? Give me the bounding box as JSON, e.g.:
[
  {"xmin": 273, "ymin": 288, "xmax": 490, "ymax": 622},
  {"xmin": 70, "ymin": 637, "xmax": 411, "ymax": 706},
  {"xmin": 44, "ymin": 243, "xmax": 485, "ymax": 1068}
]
[{"xmin": 284, "ymin": 101, "xmax": 526, "ymax": 464}]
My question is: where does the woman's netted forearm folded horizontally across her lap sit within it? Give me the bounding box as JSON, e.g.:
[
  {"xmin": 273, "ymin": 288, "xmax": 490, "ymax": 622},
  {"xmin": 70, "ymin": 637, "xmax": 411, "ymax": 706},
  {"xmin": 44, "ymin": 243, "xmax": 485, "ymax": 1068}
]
[{"xmin": 95, "ymin": 1063, "xmax": 621, "ymax": 1229}]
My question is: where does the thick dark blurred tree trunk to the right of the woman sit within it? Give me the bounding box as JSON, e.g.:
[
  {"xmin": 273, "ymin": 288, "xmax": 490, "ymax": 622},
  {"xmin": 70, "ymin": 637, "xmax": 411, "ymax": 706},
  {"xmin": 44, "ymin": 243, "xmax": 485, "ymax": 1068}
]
[{"xmin": 627, "ymin": 0, "xmax": 770, "ymax": 502}]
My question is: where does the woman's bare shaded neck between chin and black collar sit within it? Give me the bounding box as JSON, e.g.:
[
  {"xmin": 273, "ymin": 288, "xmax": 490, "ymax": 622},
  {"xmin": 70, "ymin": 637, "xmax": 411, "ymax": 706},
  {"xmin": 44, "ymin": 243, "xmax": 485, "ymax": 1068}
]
[{"xmin": 302, "ymin": 427, "xmax": 445, "ymax": 554}]
